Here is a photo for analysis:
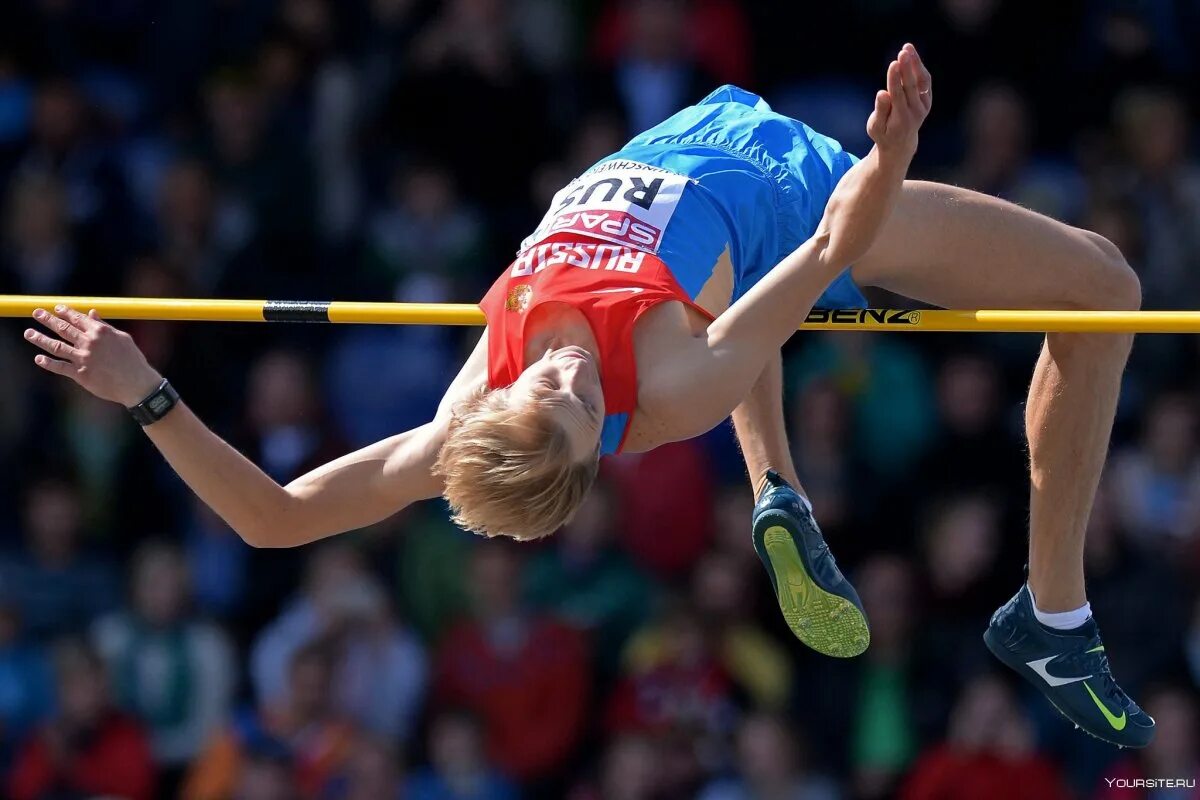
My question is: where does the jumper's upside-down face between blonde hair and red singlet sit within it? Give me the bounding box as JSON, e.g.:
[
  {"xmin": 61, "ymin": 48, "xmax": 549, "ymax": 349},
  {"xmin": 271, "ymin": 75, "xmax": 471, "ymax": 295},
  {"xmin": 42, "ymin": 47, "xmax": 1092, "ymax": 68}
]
[{"xmin": 512, "ymin": 345, "xmax": 604, "ymax": 461}]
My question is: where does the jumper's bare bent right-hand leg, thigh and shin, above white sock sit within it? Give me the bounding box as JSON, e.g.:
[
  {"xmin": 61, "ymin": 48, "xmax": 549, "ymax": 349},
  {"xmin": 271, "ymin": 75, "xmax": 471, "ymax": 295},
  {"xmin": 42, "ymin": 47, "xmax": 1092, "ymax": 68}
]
[{"xmin": 853, "ymin": 181, "xmax": 1141, "ymax": 612}]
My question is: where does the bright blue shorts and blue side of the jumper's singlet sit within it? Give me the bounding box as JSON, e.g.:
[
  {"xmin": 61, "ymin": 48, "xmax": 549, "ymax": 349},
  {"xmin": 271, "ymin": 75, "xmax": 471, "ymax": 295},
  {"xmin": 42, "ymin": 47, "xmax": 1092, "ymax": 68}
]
[{"xmin": 600, "ymin": 86, "xmax": 866, "ymax": 308}]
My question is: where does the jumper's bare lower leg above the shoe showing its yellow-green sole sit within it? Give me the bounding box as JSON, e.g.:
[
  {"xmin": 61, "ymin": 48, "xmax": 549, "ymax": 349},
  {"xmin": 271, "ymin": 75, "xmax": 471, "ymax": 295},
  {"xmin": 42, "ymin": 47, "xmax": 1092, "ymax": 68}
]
[{"xmin": 733, "ymin": 355, "xmax": 804, "ymax": 498}]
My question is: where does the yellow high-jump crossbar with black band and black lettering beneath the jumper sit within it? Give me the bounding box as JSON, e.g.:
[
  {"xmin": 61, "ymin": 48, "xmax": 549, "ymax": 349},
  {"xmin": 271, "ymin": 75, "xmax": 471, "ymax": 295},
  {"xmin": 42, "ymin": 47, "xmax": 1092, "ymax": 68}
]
[{"xmin": 0, "ymin": 295, "xmax": 1200, "ymax": 333}]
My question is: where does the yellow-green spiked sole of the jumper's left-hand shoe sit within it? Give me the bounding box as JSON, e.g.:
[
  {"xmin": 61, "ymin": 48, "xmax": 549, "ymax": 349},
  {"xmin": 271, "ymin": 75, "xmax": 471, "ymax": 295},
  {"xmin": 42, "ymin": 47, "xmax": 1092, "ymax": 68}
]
[{"xmin": 755, "ymin": 515, "xmax": 871, "ymax": 658}]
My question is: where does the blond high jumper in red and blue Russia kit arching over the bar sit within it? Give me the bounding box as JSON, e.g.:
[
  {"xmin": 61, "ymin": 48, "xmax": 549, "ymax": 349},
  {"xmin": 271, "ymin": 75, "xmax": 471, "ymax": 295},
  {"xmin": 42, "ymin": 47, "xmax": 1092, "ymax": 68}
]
[{"xmin": 25, "ymin": 44, "xmax": 1154, "ymax": 747}]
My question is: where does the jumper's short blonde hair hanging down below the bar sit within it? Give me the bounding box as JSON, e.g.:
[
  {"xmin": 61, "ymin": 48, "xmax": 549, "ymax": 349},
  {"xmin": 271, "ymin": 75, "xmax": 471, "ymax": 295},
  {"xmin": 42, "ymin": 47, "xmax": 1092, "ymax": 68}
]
[{"xmin": 433, "ymin": 389, "xmax": 600, "ymax": 540}]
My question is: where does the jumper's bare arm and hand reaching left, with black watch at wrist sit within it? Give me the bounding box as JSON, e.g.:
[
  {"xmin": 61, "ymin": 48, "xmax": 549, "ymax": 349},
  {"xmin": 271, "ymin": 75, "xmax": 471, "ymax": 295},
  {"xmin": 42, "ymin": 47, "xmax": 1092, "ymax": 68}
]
[{"xmin": 18, "ymin": 306, "xmax": 487, "ymax": 547}]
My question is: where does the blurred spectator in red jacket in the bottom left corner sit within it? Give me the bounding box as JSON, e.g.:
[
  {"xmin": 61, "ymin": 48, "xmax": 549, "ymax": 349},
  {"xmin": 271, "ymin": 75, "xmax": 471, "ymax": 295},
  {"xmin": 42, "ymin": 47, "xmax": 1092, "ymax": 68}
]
[{"xmin": 7, "ymin": 640, "xmax": 155, "ymax": 800}]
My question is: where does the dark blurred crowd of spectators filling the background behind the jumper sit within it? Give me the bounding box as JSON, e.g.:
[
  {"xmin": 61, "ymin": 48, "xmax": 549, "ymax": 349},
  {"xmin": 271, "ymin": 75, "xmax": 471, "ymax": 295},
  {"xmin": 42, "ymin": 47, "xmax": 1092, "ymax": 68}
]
[{"xmin": 0, "ymin": 0, "xmax": 1200, "ymax": 800}]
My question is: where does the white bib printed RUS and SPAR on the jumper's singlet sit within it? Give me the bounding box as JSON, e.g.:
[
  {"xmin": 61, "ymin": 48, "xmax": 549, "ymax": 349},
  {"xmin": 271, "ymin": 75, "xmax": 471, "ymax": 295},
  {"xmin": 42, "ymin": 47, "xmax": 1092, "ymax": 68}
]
[{"xmin": 521, "ymin": 161, "xmax": 691, "ymax": 253}]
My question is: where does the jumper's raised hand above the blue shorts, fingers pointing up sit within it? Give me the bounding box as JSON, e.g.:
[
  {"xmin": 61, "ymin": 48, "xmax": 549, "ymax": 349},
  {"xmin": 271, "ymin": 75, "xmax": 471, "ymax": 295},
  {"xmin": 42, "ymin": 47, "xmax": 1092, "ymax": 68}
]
[{"xmin": 866, "ymin": 44, "xmax": 934, "ymax": 157}]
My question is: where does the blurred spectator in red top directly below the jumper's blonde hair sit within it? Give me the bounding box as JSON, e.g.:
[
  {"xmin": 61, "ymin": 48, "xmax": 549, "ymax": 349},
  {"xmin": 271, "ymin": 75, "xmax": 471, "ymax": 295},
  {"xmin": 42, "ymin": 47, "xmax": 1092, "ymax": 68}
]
[{"xmin": 433, "ymin": 541, "xmax": 590, "ymax": 781}]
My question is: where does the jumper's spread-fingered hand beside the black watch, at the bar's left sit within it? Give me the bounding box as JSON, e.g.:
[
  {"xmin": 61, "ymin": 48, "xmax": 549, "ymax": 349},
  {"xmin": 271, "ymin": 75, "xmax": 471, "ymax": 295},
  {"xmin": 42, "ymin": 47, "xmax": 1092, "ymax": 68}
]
[{"xmin": 25, "ymin": 306, "xmax": 162, "ymax": 407}]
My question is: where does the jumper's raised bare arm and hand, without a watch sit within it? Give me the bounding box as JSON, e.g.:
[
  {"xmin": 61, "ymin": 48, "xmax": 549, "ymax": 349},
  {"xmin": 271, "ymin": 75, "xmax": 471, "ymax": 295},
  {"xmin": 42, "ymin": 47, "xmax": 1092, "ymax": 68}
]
[{"xmin": 677, "ymin": 44, "xmax": 932, "ymax": 433}]
